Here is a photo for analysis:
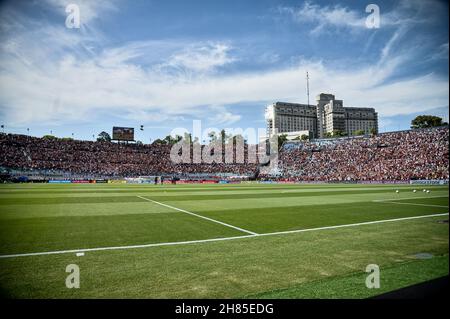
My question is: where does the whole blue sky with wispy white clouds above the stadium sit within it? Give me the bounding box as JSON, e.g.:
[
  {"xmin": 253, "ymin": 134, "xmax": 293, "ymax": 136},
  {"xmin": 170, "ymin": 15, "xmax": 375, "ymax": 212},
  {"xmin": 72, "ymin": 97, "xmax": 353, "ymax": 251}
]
[{"xmin": 0, "ymin": 0, "xmax": 449, "ymax": 143}]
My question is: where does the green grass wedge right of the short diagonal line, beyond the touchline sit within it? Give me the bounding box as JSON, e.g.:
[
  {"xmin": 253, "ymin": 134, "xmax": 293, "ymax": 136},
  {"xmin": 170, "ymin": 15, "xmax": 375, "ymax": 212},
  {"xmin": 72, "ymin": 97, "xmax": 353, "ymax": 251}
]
[{"xmin": 178, "ymin": 197, "xmax": 448, "ymax": 233}]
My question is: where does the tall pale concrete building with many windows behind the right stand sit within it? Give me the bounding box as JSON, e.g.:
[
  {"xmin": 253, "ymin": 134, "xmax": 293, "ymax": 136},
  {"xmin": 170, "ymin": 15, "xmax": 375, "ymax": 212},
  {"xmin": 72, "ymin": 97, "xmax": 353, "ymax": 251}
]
[{"xmin": 265, "ymin": 93, "xmax": 378, "ymax": 138}]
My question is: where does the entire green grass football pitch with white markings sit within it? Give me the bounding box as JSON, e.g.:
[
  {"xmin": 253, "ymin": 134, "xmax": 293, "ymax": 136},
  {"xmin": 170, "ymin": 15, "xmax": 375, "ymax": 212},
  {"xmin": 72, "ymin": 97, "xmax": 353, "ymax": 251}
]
[{"xmin": 0, "ymin": 183, "xmax": 449, "ymax": 298}]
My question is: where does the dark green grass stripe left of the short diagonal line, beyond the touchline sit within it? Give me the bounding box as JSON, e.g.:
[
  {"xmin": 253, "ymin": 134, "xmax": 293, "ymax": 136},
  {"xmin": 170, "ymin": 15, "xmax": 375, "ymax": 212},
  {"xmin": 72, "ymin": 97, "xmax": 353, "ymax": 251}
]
[{"xmin": 0, "ymin": 212, "xmax": 243, "ymax": 255}]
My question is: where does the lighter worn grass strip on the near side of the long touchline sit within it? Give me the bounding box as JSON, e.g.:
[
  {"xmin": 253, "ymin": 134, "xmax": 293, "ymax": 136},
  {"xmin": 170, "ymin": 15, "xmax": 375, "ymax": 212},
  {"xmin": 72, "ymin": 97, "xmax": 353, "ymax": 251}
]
[{"xmin": 0, "ymin": 215, "xmax": 448, "ymax": 299}]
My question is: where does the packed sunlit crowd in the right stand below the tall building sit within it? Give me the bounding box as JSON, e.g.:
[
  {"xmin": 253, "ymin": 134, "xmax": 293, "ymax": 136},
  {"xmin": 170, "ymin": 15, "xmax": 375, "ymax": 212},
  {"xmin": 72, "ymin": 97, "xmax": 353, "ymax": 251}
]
[{"xmin": 280, "ymin": 127, "xmax": 449, "ymax": 181}]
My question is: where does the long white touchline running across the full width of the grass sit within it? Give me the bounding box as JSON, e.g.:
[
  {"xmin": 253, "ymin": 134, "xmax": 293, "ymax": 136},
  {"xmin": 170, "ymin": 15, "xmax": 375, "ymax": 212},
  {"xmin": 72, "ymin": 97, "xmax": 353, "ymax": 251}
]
[{"xmin": 0, "ymin": 213, "xmax": 448, "ymax": 259}]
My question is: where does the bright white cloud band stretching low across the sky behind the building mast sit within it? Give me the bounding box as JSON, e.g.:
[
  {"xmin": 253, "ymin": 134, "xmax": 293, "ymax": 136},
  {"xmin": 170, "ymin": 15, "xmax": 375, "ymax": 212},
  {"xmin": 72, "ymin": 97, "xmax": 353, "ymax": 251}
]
[{"xmin": 0, "ymin": 39, "xmax": 448, "ymax": 124}]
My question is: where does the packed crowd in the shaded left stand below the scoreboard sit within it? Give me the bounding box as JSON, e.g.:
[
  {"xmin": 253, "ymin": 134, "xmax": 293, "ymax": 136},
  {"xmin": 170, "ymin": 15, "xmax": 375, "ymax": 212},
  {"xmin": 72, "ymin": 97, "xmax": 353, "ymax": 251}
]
[{"xmin": 0, "ymin": 134, "xmax": 257, "ymax": 177}]
